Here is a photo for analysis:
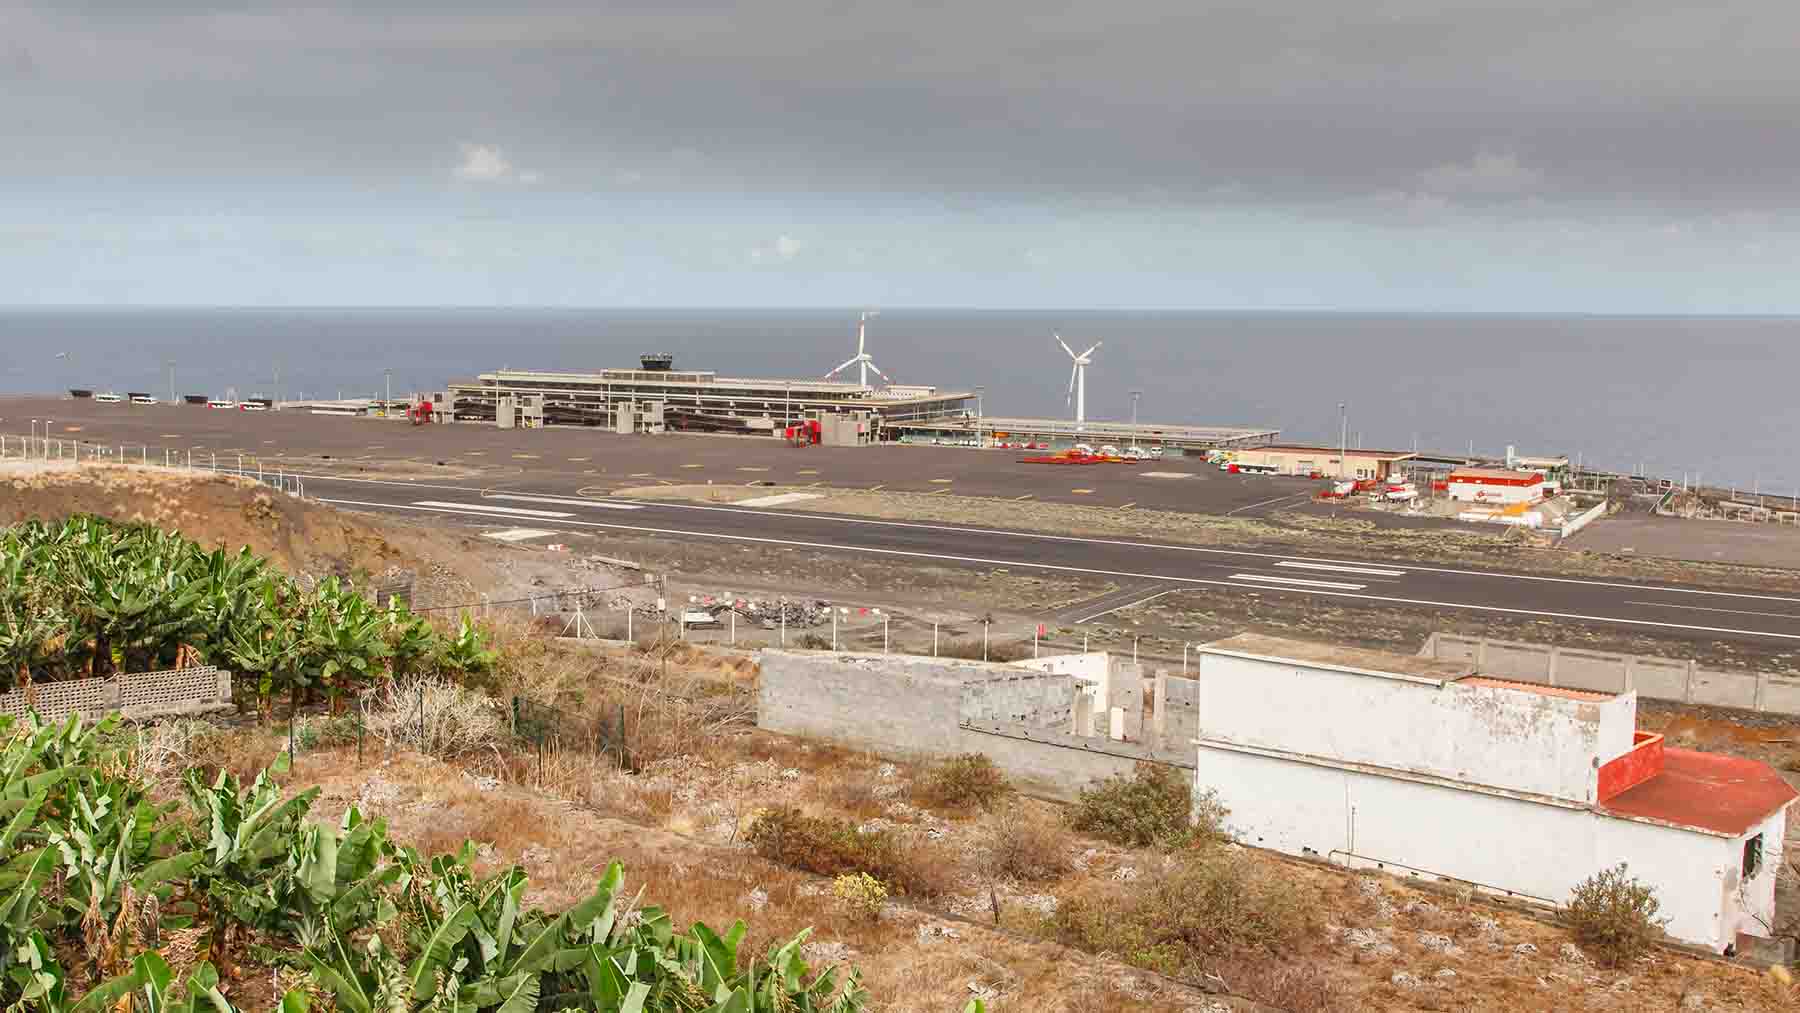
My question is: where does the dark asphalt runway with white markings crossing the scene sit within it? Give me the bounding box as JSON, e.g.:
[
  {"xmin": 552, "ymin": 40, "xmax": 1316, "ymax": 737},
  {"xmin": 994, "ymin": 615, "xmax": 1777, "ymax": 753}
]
[{"xmin": 306, "ymin": 477, "xmax": 1800, "ymax": 642}]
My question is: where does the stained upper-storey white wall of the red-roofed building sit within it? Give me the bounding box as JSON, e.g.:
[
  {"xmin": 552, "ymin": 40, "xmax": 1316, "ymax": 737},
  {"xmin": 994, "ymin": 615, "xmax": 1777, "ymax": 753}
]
[{"xmin": 1199, "ymin": 653, "xmax": 1634, "ymax": 802}]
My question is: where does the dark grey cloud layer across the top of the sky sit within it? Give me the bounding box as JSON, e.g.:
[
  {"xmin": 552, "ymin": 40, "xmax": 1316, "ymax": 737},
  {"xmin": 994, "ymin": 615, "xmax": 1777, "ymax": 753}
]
[{"xmin": 0, "ymin": 0, "xmax": 1800, "ymax": 211}]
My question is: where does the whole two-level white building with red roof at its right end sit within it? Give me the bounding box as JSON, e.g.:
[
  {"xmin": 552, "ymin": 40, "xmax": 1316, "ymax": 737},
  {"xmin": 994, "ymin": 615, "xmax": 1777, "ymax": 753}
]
[{"xmin": 1195, "ymin": 635, "xmax": 1796, "ymax": 952}]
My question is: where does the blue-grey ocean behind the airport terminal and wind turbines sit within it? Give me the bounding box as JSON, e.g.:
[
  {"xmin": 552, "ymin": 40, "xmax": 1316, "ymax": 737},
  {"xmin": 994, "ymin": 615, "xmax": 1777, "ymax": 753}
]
[{"xmin": 0, "ymin": 308, "xmax": 1800, "ymax": 495}]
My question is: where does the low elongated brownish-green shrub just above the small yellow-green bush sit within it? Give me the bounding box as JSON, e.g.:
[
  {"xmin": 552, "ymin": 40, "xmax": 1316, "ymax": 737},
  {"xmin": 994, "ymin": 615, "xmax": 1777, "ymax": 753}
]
[{"xmin": 745, "ymin": 808, "xmax": 956, "ymax": 898}]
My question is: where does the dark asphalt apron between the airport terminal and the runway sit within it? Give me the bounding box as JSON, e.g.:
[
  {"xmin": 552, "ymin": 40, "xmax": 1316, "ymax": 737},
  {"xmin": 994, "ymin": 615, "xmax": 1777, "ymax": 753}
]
[{"xmin": 0, "ymin": 398, "xmax": 1316, "ymax": 516}]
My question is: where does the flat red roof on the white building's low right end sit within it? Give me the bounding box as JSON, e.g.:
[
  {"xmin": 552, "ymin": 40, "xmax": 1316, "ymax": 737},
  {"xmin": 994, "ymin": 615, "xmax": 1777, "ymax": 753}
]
[{"xmin": 1600, "ymin": 749, "xmax": 1800, "ymax": 837}]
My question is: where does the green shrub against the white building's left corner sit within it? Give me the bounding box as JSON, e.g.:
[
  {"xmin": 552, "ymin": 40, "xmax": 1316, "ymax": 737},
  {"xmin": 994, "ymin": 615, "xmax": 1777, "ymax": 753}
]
[{"xmin": 1069, "ymin": 763, "xmax": 1228, "ymax": 847}]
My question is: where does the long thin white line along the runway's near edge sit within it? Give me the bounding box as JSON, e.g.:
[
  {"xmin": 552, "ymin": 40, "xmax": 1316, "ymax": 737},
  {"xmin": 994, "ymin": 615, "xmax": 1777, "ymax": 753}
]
[{"xmin": 317, "ymin": 500, "xmax": 1800, "ymax": 641}]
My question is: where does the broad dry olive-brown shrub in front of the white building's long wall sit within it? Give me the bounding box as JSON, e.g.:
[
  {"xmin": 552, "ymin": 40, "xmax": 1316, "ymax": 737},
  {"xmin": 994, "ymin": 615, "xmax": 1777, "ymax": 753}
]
[{"xmin": 1046, "ymin": 851, "xmax": 1310, "ymax": 979}]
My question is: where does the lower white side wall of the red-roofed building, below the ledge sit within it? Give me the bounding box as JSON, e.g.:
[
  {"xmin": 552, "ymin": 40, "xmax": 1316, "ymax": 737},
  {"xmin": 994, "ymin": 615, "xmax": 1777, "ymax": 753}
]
[{"xmin": 1195, "ymin": 743, "xmax": 1742, "ymax": 950}]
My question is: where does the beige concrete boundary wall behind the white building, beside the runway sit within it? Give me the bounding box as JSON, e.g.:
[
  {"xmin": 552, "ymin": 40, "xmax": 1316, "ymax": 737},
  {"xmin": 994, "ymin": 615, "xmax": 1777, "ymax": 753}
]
[{"xmin": 1418, "ymin": 633, "xmax": 1800, "ymax": 714}]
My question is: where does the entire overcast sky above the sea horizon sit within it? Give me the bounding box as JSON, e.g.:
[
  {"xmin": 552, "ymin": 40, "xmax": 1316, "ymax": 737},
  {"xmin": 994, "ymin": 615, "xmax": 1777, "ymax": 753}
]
[{"xmin": 0, "ymin": 0, "xmax": 1800, "ymax": 313}]
